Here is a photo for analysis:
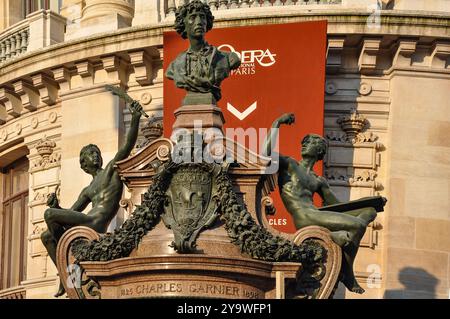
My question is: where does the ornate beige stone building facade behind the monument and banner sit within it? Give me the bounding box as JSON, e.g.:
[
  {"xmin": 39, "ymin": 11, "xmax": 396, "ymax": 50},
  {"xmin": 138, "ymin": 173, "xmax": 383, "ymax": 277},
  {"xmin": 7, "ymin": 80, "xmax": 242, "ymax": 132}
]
[{"xmin": 0, "ymin": 0, "xmax": 450, "ymax": 298}]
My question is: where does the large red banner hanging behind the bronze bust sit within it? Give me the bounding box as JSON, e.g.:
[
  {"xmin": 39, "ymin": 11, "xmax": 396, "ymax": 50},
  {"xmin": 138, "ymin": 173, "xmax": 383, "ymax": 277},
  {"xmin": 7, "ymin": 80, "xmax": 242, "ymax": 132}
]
[{"xmin": 164, "ymin": 21, "xmax": 327, "ymax": 232}]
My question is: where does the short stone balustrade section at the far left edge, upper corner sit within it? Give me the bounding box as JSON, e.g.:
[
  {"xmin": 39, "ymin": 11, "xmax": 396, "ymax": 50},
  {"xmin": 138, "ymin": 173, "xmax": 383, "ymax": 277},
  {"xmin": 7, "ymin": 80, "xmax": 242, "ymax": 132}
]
[{"xmin": 0, "ymin": 20, "xmax": 30, "ymax": 63}]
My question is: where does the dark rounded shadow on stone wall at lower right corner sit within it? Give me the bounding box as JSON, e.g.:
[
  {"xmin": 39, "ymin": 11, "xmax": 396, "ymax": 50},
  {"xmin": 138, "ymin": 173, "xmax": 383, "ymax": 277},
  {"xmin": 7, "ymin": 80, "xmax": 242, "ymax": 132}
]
[{"xmin": 384, "ymin": 267, "xmax": 439, "ymax": 299}]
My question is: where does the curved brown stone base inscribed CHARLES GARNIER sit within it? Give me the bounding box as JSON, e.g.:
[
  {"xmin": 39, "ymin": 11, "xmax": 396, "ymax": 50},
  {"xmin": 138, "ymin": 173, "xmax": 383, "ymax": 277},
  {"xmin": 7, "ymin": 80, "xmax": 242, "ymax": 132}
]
[{"xmin": 81, "ymin": 254, "xmax": 301, "ymax": 299}]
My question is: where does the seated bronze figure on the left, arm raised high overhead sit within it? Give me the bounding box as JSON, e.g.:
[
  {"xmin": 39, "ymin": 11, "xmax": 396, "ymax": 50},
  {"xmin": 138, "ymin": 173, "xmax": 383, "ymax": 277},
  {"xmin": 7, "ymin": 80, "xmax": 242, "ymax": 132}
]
[{"xmin": 41, "ymin": 101, "xmax": 142, "ymax": 296}]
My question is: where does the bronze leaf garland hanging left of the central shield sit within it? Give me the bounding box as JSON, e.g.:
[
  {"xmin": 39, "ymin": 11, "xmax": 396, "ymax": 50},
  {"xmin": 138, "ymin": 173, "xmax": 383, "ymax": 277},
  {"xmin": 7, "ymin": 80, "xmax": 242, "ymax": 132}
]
[{"xmin": 72, "ymin": 163, "xmax": 174, "ymax": 262}]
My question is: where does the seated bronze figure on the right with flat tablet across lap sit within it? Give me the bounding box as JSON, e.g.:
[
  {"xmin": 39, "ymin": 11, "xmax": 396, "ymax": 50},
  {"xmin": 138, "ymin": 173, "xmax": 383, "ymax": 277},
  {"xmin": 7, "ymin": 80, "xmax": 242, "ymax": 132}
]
[{"xmin": 264, "ymin": 114, "xmax": 386, "ymax": 294}]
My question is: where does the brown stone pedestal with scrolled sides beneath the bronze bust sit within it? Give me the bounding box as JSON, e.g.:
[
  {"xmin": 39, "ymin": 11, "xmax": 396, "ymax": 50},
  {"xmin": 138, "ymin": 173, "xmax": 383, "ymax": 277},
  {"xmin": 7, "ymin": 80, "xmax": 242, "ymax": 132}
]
[{"xmin": 58, "ymin": 105, "xmax": 341, "ymax": 299}]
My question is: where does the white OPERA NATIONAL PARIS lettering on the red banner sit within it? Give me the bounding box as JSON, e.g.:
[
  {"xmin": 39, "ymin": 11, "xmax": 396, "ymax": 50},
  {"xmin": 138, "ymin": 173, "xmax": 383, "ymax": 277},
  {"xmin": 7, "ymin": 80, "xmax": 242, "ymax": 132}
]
[{"xmin": 218, "ymin": 44, "xmax": 277, "ymax": 75}]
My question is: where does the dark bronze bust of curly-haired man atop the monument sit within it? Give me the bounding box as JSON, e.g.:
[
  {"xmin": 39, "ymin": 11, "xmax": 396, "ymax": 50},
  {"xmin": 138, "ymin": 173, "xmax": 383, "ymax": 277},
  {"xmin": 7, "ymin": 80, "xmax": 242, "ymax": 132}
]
[{"xmin": 166, "ymin": 0, "xmax": 241, "ymax": 104}]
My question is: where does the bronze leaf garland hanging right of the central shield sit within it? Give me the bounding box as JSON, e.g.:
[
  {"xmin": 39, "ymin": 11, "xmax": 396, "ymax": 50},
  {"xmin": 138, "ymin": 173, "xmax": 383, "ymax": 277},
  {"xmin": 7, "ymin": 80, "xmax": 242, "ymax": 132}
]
[{"xmin": 217, "ymin": 171, "xmax": 324, "ymax": 268}]
